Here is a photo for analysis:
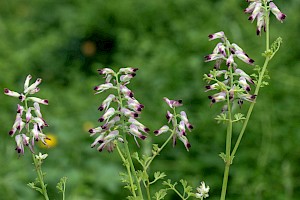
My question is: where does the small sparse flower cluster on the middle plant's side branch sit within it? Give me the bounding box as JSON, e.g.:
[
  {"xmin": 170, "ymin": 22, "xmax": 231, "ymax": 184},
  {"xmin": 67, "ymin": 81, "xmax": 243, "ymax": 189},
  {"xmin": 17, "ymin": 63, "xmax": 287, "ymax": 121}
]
[{"xmin": 154, "ymin": 97, "xmax": 193, "ymax": 151}]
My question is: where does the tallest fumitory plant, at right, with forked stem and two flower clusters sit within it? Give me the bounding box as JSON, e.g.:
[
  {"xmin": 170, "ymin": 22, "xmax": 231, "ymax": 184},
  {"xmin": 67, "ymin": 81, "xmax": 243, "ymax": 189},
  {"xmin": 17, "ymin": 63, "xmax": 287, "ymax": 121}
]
[{"xmin": 204, "ymin": 0, "xmax": 286, "ymax": 200}]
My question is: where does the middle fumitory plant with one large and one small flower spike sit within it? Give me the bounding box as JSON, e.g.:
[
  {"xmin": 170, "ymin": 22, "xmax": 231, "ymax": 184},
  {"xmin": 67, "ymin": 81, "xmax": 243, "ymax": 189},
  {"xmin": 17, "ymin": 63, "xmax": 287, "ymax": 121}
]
[{"xmin": 89, "ymin": 67, "xmax": 209, "ymax": 200}]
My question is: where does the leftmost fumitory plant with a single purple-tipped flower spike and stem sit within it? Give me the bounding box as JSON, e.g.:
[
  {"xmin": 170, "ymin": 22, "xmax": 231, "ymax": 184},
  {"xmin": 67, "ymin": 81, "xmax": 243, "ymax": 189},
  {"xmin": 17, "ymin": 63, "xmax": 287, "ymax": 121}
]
[{"xmin": 4, "ymin": 75, "xmax": 66, "ymax": 200}]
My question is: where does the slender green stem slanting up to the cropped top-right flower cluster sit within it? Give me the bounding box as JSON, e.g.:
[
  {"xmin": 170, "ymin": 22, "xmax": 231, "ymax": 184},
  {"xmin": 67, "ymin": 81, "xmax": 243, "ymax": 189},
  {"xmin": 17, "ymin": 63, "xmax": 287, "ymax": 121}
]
[{"xmin": 231, "ymin": 9, "xmax": 270, "ymax": 158}]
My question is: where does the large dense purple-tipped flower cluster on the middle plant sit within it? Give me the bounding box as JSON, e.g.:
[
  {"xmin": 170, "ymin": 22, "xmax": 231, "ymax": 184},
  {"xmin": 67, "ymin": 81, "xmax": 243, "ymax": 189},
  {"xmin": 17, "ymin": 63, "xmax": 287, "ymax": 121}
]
[{"xmin": 89, "ymin": 67, "xmax": 150, "ymax": 152}]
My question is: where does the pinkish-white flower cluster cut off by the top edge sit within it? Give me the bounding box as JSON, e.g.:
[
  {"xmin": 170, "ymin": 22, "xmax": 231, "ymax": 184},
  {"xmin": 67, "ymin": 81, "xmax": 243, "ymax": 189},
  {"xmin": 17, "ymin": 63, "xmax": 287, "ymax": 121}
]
[{"xmin": 244, "ymin": 0, "xmax": 286, "ymax": 35}]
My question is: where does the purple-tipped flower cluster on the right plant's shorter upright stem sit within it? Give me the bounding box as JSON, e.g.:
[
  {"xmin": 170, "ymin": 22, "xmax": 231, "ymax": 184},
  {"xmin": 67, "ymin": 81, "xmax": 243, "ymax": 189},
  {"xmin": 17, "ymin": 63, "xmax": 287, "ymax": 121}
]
[{"xmin": 204, "ymin": 31, "xmax": 256, "ymax": 110}]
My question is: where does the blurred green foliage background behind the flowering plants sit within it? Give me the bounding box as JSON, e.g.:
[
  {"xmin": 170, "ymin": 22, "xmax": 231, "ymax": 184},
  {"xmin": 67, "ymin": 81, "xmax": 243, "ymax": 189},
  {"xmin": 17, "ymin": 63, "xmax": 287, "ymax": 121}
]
[{"xmin": 0, "ymin": 0, "xmax": 300, "ymax": 200}]
